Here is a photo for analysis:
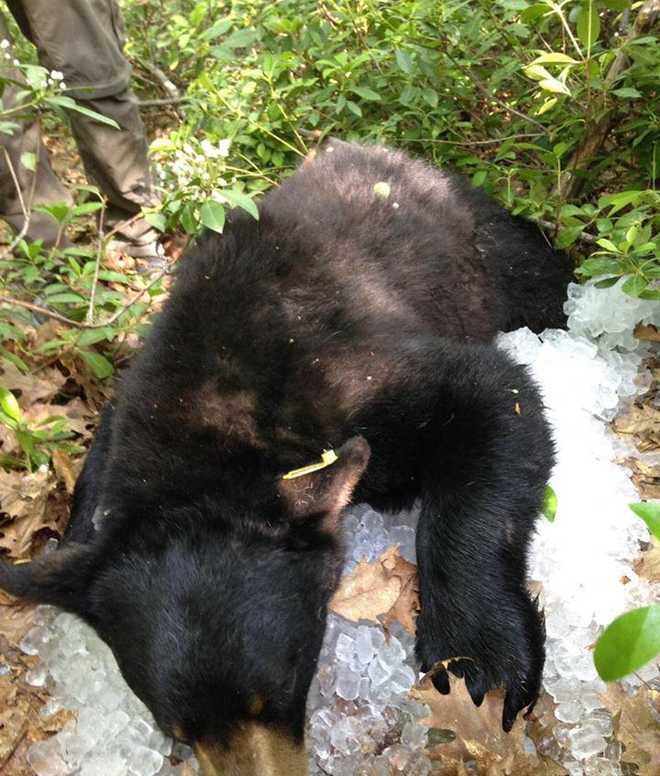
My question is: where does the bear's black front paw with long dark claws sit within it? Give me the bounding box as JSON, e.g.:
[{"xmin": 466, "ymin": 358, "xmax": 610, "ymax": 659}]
[{"xmin": 416, "ymin": 593, "xmax": 545, "ymax": 733}]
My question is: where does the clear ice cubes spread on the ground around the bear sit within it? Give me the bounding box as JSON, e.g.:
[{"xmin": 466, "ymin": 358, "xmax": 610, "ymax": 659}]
[{"xmin": 22, "ymin": 284, "xmax": 660, "ymax": 776}]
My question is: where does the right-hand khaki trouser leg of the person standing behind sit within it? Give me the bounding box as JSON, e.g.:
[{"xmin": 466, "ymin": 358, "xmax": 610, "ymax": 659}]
[{"xmin": 10, "ymin": 0, "xmax": 154, "ymax": 229}]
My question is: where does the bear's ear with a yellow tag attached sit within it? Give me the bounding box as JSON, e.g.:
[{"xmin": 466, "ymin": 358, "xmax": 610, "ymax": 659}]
[{"xmin": 279, "ymin": 437, "xmax": 371, "ymax": 530}]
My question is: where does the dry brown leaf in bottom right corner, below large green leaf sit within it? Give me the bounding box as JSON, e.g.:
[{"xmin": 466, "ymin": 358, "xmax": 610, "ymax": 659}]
[{"xmin": 603, "ymin": 684, "xmax": 660, "ymax": 776}]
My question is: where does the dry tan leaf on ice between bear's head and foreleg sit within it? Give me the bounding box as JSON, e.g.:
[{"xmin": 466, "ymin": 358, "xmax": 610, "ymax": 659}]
[{"xmin": 330, "ymin": 545, "xmax": 419, "ymax": 636}]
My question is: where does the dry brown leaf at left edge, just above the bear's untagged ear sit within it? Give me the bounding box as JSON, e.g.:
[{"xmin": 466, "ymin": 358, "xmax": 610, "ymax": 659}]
[{"xmin": 0, "ymin": 466, "xmax": 58, "ymax": 559}]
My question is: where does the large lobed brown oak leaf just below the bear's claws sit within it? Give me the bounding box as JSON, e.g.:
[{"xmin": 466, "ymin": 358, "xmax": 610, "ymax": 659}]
[{"xmin": 410, "ymin": 675, "xmax": 565, "ymax": 776}]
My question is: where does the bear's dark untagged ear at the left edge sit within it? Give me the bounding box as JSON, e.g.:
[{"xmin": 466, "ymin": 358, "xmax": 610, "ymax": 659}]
[{"xmin": 0, "ymin": 542, "xmax": 95, "ymax": 617}]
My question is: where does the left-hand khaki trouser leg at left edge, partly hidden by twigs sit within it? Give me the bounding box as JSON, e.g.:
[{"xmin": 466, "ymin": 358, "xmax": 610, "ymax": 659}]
[{"xmin": 0, "ymin": 14, "xmax": 73, "ymax": 246}]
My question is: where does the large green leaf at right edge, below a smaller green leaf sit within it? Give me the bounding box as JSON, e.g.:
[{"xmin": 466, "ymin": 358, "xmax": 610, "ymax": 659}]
[{"xmin": 594, "ymin": 604, "xmax": 660, "ymax": 682}]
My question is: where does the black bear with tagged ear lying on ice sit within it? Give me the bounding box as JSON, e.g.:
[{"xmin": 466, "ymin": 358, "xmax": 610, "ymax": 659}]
[{"xmin": 0, "ymin": 141, "xmax": 571, "ymax": 776}]
